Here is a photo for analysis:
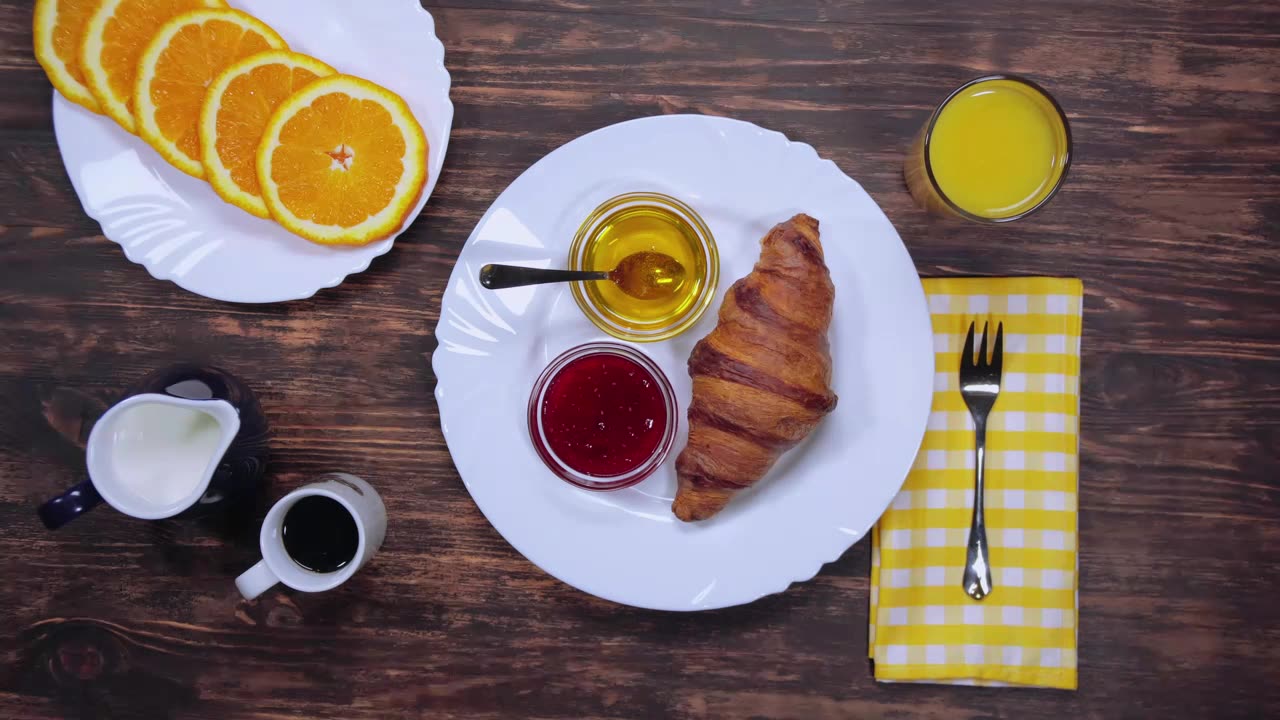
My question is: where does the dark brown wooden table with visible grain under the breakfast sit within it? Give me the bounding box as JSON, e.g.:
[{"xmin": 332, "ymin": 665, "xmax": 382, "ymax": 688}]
[{"xmin": 0, "ymin": 0, "xmax": 1280, "ymax": 720}]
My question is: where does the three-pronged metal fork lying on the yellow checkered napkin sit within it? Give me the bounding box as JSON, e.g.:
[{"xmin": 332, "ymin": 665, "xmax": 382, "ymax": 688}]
[{"xmin": 960, "ymin": 323, "xmax": 1005, "ymax": 600}]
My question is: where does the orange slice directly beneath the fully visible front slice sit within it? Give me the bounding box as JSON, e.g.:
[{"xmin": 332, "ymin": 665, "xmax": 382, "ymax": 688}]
[{"xmin": 200, "ymin": 50, "xmax": 335, "ymax": 218}]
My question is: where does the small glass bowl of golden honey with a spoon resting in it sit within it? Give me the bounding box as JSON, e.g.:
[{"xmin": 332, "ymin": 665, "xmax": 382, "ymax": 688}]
[{"xmin": 568, "ymin": 192, "xmax": 719, "ymax": 342}]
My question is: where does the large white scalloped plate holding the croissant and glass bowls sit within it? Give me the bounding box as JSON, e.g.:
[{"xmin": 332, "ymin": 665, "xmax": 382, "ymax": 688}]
[{"xmin": 433, "ymin": 115, "xmax": 933, "ymax": 610}]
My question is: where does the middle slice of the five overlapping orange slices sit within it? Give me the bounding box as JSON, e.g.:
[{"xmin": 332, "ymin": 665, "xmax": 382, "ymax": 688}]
[{"xmin": 133, "ymin": 10, "xmax": 285, "ymax": 178}]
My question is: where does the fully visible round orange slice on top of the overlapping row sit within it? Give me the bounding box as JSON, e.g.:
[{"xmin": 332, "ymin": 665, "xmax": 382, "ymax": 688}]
[{"xmin": 257, "ymin": 76, "xmax": 429, "ymax": 245}]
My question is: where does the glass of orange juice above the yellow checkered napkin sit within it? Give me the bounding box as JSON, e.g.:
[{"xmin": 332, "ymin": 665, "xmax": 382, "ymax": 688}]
[{"xmin": 904, "ymin": 74, "xmax": 1071, "ymax": 223}]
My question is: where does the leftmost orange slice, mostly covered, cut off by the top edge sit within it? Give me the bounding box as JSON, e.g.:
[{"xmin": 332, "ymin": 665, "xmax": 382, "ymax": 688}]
[{"xmin": 32, "ymin": 0, "xmax": 102, "ymax": 113}]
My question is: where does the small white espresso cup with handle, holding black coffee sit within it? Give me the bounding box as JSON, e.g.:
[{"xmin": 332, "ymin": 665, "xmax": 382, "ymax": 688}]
[{"xmin": 236, "ymin": 473, "xmax": 387, "ymax": 600}]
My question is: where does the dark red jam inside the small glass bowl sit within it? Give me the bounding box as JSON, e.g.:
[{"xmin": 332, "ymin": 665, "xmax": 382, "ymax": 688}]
[{"xmin": 541, "ymin": 354, "xmax": 667, "ymax": 478}]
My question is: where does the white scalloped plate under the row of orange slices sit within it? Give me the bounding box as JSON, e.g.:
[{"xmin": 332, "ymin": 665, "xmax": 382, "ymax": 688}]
[{"xmin": 54, "ymin": 0, "xmax": 453, "ymax": 302}]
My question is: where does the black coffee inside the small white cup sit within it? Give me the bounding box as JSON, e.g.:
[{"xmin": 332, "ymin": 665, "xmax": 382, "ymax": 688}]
[{"xmin": 282, "ymin": 495, "xmax": 360, "ymax": 573}]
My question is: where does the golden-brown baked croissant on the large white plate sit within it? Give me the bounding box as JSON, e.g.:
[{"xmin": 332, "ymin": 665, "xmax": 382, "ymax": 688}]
[{"xmin": 671, "ymin": 214, "xmax": 836, "ymax": 521}]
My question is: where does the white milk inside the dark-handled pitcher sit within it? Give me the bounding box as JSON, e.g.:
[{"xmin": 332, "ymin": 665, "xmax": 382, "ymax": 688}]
[{"xmin": 110, "ymin": 404, "xmax": 223, "ymax": 506}]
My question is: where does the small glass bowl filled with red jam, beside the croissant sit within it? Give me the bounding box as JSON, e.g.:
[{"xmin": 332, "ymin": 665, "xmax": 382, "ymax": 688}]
[{"xmin": 529, "ymin": 342, "xmax": 677, "ymax": 491}]
